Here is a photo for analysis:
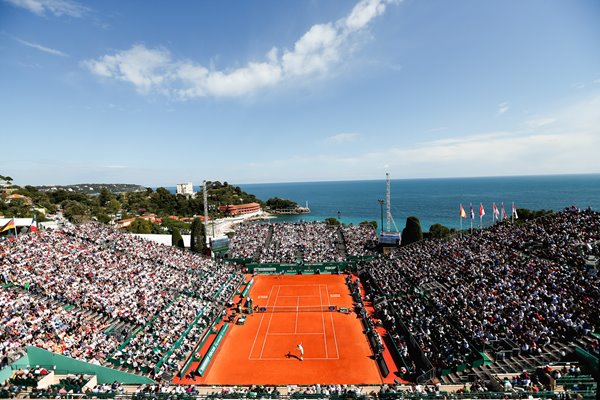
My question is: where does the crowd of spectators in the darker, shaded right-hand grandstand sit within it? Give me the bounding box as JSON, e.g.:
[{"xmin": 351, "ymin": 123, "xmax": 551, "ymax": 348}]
[{"xmin": 363, "ymin": 211, "xmax": 600, "ymax": 376}]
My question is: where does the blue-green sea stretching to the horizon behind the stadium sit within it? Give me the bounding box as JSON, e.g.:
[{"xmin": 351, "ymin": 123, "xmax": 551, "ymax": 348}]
[{"xmin": 169, "ymin": 174, "xmax": 600, "ymax": 231}]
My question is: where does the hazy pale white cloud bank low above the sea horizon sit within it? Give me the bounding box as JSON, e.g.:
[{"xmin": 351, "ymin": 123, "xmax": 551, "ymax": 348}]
[{"xmin": 239, "ymin": 96, "xmax": 600, "ymax": 182}]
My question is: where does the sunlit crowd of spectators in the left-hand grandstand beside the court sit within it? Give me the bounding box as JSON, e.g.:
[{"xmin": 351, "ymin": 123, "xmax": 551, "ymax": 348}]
[{"xmin": 0, "ymin": 223, "xmax": 242, "ymax": 377}]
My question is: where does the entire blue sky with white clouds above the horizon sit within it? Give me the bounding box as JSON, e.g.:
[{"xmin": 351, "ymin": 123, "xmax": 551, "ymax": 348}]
[{"xmin": 0, "ymin": 0, "xmax": 600, "ymax": 186}]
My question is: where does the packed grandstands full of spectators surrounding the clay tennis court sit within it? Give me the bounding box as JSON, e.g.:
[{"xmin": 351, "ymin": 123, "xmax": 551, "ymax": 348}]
[{"xmin": 0, "ymin": 210, "xmax": 600, "ymax": 398}]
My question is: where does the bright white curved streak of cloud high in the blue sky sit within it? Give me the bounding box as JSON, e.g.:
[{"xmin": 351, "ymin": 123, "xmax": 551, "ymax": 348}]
[{"xmin": 82, "ymin": 0, "xmax": 398, "ymax": 100}]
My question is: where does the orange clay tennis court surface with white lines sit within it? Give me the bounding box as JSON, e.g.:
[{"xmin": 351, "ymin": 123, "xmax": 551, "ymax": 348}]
[{"xmin": 174, "ymin": 275, "xmax": 386, "ymax": 385}]
